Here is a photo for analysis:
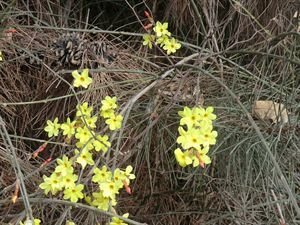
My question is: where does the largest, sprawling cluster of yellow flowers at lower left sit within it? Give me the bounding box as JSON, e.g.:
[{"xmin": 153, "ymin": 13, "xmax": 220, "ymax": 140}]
[{"xmin": 39, "ymin": 96, "xmax": 135, "ymax": 224}]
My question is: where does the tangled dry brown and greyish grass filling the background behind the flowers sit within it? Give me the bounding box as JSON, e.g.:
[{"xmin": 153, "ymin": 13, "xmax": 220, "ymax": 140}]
[{"xmin": 0, "ymin": 0, "xmax": 300, "ymax": 225}]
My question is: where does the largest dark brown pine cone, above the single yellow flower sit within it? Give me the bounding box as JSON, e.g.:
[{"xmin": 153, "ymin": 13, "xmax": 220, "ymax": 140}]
[{"xmin": 53, "ymin": 33, "xmax": 86, "ymax": 66}]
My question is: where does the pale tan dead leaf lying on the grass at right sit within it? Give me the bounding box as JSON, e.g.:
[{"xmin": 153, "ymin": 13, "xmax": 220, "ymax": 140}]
[{"xmin": 252, "ymin": 101, "xmax": 289, "ymax": 124}]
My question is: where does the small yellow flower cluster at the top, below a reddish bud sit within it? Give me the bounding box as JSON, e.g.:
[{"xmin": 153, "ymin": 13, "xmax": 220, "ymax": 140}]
[{"xmin": 143, "ymin": 21, "xmax": 181, "ymax": 55}]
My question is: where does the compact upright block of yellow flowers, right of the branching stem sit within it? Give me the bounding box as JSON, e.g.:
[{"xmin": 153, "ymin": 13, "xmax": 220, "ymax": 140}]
[{"xmin": 174, "ymin": 107, "xmax": 218, "ymax": 167}]
